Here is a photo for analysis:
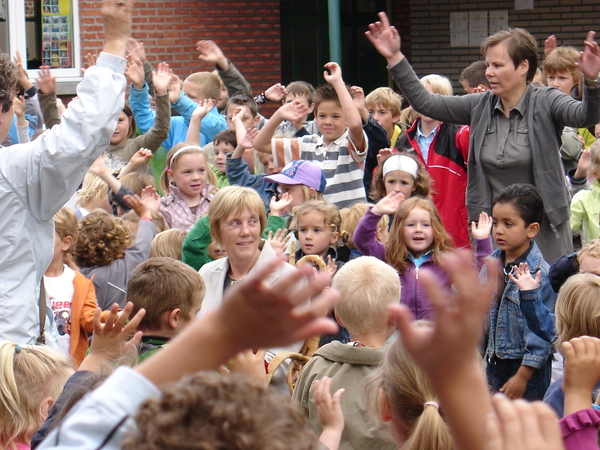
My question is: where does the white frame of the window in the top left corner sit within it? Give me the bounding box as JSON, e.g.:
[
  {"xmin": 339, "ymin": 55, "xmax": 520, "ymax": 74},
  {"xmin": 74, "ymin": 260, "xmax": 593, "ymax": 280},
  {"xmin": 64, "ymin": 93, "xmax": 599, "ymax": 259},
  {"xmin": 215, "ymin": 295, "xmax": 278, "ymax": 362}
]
[{"xmin": 6, "ymin": 0, "xmax": 81, "ymax": 83}]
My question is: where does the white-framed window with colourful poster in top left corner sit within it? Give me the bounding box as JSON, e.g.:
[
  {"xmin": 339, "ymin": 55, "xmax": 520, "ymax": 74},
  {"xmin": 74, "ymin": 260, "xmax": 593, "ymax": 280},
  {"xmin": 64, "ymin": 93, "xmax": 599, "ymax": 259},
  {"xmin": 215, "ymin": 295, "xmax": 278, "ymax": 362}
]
[{"xmin": 0, "ymin": 0, "xmax": 81, "ymax": 83}]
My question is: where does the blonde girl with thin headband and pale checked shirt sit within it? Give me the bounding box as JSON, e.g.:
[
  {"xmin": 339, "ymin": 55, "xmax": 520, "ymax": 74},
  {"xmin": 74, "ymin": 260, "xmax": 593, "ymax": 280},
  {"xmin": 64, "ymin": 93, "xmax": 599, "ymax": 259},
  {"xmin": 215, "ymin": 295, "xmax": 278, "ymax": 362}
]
[{"xmin": 160, "ymin": 143, "xmax": 216, "ymax": 231}]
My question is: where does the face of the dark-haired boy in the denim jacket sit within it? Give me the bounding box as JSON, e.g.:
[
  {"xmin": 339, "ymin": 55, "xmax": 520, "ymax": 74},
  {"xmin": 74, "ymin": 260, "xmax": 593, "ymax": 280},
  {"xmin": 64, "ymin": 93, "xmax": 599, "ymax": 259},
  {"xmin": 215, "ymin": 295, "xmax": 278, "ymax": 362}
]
[{"xmin": 492, "ymin": 203, "xmax": 539, "ymax": 262}]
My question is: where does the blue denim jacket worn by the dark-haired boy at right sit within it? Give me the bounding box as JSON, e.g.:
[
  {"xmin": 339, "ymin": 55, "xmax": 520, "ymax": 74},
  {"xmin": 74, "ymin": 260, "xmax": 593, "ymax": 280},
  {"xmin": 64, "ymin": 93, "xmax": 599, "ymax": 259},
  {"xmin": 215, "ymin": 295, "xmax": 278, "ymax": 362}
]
[{"xmin": 482, "ymin": 241, "xmax": 556, "ymax": 369}]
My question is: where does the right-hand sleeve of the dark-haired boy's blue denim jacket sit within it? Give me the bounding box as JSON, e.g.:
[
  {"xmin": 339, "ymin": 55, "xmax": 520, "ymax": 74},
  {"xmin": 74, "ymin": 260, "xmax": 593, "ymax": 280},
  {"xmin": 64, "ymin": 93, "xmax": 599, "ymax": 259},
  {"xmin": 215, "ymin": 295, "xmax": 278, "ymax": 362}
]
[{"xmin": 520, "ymin": 273, "xmax": 556, "ymax": 369}]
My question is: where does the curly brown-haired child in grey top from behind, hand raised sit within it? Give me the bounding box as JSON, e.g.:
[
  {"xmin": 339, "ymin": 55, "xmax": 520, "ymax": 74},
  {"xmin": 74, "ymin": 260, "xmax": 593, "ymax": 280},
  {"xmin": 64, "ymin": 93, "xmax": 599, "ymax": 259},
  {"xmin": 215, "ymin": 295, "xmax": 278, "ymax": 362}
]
[{"xmin": 73, "ymin": 189, "xmax": 156, "ymax": 310}]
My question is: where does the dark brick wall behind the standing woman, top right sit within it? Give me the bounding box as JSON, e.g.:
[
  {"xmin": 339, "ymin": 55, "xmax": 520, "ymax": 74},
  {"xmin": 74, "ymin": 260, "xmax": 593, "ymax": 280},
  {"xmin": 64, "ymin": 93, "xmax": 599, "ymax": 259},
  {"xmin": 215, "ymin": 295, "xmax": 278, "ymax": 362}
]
[{"xmin": 410, "ymin": 0, "xmax": 600, "ymax": 93}]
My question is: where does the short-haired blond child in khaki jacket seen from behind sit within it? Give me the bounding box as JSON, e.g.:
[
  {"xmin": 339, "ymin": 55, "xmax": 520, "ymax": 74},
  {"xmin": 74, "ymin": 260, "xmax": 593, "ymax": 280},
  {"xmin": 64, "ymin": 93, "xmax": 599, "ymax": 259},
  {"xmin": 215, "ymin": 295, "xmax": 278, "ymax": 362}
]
[{"xmin": 292, "ymin": 256, "xmax": 400, "ymax": 450}]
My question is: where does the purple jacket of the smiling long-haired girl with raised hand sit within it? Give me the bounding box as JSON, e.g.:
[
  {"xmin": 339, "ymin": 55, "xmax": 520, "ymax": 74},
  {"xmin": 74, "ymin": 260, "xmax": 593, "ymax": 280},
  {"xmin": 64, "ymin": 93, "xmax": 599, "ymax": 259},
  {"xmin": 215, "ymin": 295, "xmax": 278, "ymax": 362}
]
[{"xmin": 353, "ymin": 208, "xmax": 492, "ymax": 320}]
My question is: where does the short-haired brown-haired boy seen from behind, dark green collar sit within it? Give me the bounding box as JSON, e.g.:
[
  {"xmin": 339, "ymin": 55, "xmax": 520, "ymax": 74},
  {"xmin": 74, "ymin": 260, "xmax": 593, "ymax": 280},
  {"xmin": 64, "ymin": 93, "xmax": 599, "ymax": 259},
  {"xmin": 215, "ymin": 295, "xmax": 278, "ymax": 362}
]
[{"xmin": 127, "ymin": 256, "xmax": 206, "ymax": 361}]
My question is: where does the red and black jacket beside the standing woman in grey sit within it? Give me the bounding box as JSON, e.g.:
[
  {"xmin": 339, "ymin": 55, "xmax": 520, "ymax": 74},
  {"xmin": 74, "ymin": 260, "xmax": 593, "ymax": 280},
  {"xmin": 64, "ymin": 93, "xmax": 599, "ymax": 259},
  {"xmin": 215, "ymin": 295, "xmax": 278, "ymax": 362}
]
[{"xmin": 397, "ymin": 119, "xmax": 470, "ymax": 248}]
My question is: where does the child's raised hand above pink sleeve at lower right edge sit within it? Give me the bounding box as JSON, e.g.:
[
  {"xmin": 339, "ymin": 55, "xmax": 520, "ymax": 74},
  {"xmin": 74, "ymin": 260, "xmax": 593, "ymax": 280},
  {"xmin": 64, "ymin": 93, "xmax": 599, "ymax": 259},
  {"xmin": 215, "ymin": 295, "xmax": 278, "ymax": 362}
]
[{"xmin": 562, "ymin": 336, "xmax": 600, "ymax": 415}]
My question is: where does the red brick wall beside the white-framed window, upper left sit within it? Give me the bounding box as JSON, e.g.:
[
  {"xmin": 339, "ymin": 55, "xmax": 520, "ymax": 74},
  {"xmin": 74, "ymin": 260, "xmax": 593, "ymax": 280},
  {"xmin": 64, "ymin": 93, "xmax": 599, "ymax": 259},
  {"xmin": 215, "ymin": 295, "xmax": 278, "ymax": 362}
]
[{"xmin": 79, "ymin": 0, "xmax": 281, "ymax": 99}]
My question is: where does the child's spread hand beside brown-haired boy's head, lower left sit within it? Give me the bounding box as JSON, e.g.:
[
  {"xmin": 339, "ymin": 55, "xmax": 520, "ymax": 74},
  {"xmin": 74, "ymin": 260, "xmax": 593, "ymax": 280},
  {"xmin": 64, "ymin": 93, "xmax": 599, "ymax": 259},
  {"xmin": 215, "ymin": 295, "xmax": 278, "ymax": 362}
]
[{"xmin": 79, "ymin": 302, "xmax": 146, "ymax": 371}]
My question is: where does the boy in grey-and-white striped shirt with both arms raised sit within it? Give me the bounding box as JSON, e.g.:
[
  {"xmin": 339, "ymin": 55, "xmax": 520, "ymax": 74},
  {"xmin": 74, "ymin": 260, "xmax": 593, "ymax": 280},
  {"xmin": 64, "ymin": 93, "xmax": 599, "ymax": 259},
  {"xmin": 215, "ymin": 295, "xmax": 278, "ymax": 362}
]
[{"xmin": 254, "ymin": 63, "xmax": 368, "ymax": 208}]
